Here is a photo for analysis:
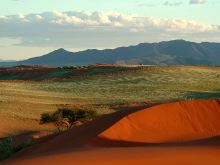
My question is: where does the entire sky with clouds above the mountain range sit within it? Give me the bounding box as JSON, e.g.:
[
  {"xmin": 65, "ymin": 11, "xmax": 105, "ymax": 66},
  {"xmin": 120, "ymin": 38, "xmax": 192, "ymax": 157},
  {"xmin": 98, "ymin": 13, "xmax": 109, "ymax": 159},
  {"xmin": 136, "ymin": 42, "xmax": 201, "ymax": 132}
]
[{"xmin": 0, "ymin": 0, "xmax": 220, "ymax": 60}]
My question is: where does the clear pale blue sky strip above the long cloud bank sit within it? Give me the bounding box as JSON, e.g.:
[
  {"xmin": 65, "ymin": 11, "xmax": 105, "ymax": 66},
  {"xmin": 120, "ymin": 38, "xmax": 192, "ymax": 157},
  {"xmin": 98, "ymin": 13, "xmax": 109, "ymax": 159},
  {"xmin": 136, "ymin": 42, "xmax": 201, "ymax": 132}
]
[{"xmin": 0, "ymin": 0, "xmax": 220, "ymax": 24}]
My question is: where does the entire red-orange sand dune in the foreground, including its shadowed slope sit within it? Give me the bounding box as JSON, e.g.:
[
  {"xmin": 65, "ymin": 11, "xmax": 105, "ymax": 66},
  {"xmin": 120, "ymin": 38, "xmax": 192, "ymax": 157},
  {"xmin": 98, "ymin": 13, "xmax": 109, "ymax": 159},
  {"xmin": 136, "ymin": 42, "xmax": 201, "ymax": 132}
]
[{"xmin": 4, "ymin": 100, "xmax": 220, "ymax": 165}]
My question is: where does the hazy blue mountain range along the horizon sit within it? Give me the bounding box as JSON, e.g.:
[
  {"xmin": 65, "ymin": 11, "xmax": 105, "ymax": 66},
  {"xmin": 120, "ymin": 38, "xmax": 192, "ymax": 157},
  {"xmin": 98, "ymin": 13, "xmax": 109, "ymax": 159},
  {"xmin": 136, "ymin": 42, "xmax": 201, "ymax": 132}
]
[{"xmin": 0, "ymin": 40, "xmax": 220, "ymax": 66}]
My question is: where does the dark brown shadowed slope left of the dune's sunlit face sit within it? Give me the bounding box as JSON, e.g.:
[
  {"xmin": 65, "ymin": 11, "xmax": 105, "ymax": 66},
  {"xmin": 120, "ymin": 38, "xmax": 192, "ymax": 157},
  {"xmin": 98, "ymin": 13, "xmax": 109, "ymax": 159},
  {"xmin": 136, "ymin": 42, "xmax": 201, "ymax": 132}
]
[{"xmin": 7, "ymin": 105, "xmax": 149, "ymax": 159}]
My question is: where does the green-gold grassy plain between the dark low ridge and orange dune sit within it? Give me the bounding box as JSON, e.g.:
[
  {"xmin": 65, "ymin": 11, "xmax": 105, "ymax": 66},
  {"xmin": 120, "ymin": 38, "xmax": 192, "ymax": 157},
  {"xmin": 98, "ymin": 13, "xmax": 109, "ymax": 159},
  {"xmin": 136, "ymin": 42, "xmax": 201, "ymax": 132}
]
[{"xmin": 0, "ymin": 66, "xmax": 220, "ymax": 137}]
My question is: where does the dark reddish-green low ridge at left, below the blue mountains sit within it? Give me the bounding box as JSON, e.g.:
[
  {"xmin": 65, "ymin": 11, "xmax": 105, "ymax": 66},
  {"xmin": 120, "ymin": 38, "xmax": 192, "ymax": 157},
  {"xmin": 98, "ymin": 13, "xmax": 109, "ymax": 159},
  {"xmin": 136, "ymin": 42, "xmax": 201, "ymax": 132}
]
[{"xmin": 0, "ymin": 65, "xmax": 134, "ymax": 80}]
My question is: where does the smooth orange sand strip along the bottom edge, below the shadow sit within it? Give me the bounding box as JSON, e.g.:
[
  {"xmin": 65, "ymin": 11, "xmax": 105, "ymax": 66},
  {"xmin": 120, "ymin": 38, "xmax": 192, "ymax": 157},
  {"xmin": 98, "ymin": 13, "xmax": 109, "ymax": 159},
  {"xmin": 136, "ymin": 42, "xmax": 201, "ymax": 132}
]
[{"xmin": 3, "ymin": 147, "xmax": 220, "ymax": 165}]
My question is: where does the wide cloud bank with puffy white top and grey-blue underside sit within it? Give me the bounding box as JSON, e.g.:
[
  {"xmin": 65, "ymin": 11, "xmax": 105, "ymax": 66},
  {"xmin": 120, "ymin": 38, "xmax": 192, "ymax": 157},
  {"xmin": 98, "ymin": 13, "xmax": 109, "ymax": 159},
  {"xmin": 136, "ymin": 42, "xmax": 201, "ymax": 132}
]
[{"xmin": 0, "ymin": 10, "xmax": 220, "ymax": 49}]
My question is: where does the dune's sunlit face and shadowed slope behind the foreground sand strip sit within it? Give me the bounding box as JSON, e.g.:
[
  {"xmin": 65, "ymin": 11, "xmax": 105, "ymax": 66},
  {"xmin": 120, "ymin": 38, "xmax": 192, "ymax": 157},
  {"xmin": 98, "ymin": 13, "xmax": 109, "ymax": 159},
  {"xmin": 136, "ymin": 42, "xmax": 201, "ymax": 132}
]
[{"xmin": 3, "ymin": 100, "xmax": 220, "ymax": 162}]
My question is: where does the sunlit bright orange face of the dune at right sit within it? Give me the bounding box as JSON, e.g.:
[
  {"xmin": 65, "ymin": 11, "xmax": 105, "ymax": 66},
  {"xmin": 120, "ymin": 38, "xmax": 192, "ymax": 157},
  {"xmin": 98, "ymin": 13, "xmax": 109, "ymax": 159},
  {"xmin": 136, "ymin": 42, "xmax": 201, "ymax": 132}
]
[{"xmin": 96, "ymin": 100, "xmax": 220, "ymax": 143}]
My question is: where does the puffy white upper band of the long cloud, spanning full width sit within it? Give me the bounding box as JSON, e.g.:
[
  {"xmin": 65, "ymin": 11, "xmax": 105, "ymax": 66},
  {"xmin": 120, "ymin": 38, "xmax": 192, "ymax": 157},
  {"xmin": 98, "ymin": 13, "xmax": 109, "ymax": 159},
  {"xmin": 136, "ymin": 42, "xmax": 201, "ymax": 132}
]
[{"xmin": 0, "ymin": 11, "xmax": 219, "ymax": 33}]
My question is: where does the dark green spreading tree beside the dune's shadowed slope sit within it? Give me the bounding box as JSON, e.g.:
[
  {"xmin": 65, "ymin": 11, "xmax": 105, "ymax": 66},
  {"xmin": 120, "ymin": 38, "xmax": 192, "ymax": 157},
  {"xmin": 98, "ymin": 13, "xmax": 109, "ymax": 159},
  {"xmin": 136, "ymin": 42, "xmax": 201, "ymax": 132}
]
[{"xmin": 40, "ymin": 108, "xmax": 99, "ymax": 132}]
